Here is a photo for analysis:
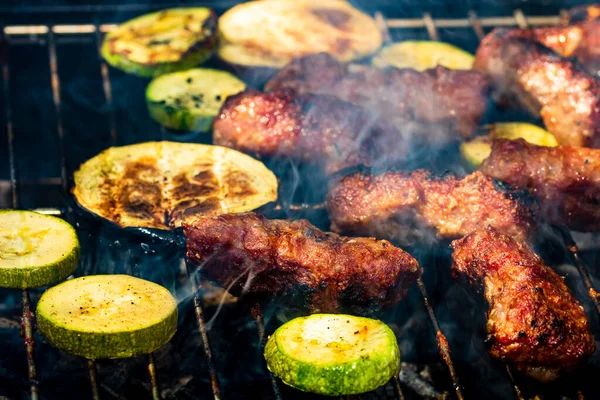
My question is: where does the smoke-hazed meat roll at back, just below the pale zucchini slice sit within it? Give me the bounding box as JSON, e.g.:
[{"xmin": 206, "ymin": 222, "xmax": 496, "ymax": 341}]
[{"xmin": 265, "ymin": 53, "xmax": 488, "ymax": 144}]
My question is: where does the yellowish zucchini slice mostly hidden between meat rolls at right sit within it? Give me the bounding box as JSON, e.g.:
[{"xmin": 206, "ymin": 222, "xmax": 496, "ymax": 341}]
[{"xmin": 460, "ymin": 122, "xmax": 558, "ymax": 168}]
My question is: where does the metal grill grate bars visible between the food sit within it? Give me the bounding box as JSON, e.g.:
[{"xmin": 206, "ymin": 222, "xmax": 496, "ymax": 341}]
[{"xmin": 0, "ymin": 6, "xmax": 600, "ymax": 400}]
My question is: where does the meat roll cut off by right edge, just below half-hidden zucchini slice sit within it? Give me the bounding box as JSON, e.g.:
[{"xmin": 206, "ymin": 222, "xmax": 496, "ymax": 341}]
[{"xmin": 480, "ymin": 139, "xmax": 600, "ymax": 232}]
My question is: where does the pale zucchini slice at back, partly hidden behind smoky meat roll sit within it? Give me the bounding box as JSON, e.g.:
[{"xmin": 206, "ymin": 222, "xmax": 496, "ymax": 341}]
[{"xmin": 372, "ymin": 40, "xmax": 475, "ymax": 71}]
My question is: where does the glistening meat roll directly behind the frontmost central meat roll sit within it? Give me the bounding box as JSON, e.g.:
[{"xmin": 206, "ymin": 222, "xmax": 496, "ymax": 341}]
[{"xmin": 327, "ymin": 170, "xmax": 537, "ymax": 245}]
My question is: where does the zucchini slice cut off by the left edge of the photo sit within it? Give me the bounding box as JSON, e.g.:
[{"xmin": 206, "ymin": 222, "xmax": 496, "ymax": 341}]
[{"xmin": 0, "ymin": 210, "xmax": 80, "ymax": 288}]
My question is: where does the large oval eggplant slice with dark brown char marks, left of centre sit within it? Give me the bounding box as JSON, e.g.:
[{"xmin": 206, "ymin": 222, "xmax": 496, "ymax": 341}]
[{"xmin": 73, "ymin": 142, "xmax": 277, "ymax": 229}]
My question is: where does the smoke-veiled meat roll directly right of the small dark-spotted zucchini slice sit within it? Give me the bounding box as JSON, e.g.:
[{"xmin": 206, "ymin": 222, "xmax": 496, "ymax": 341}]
[{"xmin": 213, "ymin": 90, "xmax": 408, "ymax": 173}]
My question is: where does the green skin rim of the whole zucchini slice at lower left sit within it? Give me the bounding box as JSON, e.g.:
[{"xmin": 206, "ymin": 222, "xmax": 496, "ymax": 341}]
[{"xmin": 37, "ymin": 306, "xmax": 177, "ymax": 359}]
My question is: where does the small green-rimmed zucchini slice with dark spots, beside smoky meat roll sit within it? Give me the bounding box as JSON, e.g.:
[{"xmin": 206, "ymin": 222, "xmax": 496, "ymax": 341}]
[{"xmin": 146, "ymin": 68, "xmax": 246, "ymax": 132}]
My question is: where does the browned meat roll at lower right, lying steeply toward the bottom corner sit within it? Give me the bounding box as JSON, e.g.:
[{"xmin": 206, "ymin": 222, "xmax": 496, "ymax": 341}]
[{"xmin": 452, "ymin": 227, "xmax": 595, "ymax": 381}]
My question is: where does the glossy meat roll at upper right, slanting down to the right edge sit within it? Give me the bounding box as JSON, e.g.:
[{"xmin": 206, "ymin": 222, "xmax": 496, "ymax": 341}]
[{"xmin": 474, "ymin": 29, "xmax": 600, "ymax": 147}]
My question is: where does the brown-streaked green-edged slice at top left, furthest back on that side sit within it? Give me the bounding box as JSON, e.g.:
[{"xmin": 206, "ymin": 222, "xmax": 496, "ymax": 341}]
[{"xmin": 101, "ymin": 7, "xmax": 217, "ymax": 77}]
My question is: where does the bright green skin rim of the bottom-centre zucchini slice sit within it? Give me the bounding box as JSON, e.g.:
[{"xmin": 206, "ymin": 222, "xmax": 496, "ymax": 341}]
[{"xmin": 264, "ymin": 316, "xmax": 400, "ymax": 396}]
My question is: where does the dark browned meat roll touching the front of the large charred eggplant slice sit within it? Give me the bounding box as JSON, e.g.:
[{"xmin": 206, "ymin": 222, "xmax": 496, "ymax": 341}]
[{"xmin": 184, "ymin": 213, "xmax": 421, "ymax": 313}]
